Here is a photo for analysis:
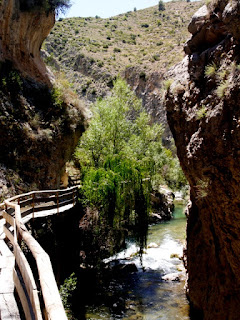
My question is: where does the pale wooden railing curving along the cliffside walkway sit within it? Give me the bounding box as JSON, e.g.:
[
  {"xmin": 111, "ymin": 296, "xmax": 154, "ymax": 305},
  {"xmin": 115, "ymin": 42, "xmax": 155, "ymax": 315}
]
[{"xmin": 0, "ymin": 187, "xmax": 78, "ymax": 320}]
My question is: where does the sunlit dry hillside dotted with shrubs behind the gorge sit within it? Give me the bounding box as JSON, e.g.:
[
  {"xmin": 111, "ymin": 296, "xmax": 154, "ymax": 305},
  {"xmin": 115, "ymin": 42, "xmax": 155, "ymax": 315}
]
[{"xmin": 43, "ymin": 1, "xmax": 202, "ymax": 118}]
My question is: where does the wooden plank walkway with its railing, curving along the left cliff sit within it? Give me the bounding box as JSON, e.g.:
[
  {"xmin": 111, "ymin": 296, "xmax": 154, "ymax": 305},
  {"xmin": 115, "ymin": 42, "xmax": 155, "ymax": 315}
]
[{"xmin": 0, "ymin": 187, "xmax": 78, "ymax": 320}]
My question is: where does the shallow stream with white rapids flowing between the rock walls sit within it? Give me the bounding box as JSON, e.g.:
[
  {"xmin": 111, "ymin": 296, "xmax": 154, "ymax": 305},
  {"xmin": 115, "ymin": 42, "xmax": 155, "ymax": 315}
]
[{"xmin": 84, "ymin": 207, "xmax": 189, "ymax": 320}]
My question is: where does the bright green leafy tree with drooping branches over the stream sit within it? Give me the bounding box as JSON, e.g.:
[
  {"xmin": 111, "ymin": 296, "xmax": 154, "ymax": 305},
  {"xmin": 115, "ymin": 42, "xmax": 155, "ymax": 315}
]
[{"xmin": 76, "ymin": 79, "xmax": 185, "ymax": 258}]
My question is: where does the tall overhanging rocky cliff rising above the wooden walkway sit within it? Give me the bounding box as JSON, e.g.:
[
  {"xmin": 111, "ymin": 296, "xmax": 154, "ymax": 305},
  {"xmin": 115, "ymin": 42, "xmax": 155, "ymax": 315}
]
[{"xmin": 0, "ymin": 0, "xmax": 86, "ymax": 198}]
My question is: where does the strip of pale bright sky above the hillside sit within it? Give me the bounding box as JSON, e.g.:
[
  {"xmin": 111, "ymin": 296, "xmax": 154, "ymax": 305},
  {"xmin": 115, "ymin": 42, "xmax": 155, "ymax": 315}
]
[{"xmin": 63, "ymin": 0, "xmax": 191, "ymax": 18}]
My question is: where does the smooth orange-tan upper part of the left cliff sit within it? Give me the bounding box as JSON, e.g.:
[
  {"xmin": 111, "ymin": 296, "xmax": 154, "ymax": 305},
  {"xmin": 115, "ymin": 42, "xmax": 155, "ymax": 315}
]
[{"xmin": 0, "ymin": 0, "xmax": 55, "ymax": 84}]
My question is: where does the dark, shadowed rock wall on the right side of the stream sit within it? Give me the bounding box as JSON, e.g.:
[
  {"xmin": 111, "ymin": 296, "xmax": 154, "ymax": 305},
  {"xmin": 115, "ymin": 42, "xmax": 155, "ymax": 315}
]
[{"xmin": 165, "ymin": 0, "xmax": 240, "ymax": 320}]
